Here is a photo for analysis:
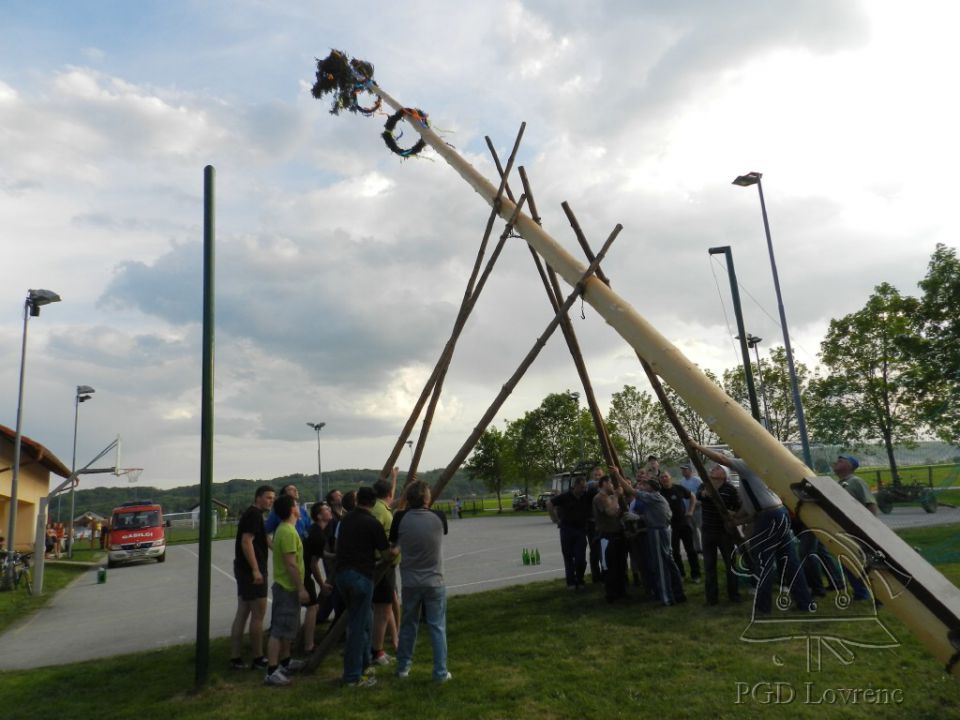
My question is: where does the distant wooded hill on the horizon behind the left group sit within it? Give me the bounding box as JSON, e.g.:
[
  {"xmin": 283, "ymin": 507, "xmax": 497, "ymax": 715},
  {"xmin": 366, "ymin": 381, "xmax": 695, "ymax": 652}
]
[{"xmin": 67, "ymin": 468, "xmax": 482, "ymax": 517}]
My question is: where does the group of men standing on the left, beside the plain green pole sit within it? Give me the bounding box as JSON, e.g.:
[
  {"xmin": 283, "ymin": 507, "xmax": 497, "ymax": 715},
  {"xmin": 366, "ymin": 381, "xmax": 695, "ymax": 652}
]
[{"xmin": 230, "ymin": 468, "xmax": 452, "ymax": 687}]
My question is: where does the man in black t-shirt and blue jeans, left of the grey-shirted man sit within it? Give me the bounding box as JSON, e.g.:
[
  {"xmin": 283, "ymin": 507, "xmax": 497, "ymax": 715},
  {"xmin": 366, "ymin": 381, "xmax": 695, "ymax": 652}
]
[{"xmin": 336, "ymin": 487, "xmax": 397, "ymax": 687}]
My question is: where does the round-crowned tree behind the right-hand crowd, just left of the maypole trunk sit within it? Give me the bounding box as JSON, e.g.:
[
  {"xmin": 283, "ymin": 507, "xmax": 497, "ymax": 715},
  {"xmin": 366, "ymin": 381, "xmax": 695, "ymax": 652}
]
[{"xmin": 608, "ymin": 385, "xmax": 682, "ymax": 474}]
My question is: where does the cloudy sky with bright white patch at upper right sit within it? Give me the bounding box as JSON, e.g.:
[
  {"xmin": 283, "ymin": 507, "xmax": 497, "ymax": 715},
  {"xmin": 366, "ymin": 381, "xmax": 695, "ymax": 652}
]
[{"xmin": 0, "ymin": 0, "xmax": 960, "ymax": 487}]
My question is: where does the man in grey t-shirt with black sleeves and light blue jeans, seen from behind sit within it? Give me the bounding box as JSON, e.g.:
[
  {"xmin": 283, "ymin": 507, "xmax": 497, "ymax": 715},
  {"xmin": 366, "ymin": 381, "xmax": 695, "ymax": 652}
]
[{"xmin": 390, "ymin": 480, "xmax": 453, "ymax": 683}]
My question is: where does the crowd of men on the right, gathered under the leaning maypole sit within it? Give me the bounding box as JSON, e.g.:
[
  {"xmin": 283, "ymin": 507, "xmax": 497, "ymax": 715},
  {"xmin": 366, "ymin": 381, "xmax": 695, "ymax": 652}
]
[{"xmin": 547, "ymin": 443, "xmax": 877, "ymax": 615}]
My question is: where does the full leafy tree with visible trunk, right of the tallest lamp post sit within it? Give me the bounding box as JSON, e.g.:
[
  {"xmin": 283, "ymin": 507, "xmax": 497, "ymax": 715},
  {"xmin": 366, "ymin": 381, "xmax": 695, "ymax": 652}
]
[{"xmin": 810, "ymin": 283, "xmax": 921, "ymax": 484}]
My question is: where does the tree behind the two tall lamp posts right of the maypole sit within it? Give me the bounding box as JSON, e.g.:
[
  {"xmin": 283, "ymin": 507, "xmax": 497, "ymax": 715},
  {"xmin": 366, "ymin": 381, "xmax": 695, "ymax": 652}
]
[{"xmin": 723, "ymin": 345, "xmax": 810, "ymax": 442}]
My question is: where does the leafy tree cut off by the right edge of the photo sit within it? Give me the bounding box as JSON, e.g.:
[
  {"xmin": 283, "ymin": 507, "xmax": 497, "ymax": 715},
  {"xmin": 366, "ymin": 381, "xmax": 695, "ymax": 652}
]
[{"xmin": 911, "ymin": 244, "xmax": 960, "ymax": 445}]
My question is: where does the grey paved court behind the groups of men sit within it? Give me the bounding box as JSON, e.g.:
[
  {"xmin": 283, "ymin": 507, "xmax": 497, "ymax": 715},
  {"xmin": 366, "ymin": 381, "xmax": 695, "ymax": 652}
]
[{"xmin": 0, "ymin": 507, "xmax": 960, "ymax": 670}]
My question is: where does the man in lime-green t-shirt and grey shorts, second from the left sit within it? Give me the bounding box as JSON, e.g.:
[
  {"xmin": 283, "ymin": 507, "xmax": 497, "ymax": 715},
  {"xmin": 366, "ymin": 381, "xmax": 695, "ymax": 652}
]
[{"xmin": 263, "ymin": 495, "xmax": 310, "ymax": 685}]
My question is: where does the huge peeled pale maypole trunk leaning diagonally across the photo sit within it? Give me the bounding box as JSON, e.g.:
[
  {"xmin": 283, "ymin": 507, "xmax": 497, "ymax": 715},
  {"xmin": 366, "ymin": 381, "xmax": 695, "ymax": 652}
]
[{"xmin": 362, "ymin": 83, "xmax": 960, "ymax": 674}]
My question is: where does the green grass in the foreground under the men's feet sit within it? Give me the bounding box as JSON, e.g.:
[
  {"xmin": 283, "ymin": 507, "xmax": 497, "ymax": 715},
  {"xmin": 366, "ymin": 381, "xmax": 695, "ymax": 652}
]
[{"xmin": 0, "ymin": 525, "xmax": 960, "ymax": 720}]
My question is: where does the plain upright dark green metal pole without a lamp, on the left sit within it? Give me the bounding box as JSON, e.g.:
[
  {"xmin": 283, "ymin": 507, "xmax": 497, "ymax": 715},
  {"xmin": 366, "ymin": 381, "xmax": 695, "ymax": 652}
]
[{"xmin": 194, "ymin": 165, "xmax": 216, "ymax": 688}]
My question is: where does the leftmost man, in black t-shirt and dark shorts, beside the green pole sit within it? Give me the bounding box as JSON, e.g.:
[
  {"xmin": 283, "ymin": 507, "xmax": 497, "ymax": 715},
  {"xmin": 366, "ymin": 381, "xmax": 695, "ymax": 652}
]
[{"xmin": 230, "ymin": 485, "xmax": 276, "ymax": 670}]
